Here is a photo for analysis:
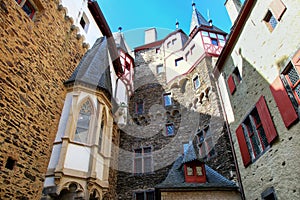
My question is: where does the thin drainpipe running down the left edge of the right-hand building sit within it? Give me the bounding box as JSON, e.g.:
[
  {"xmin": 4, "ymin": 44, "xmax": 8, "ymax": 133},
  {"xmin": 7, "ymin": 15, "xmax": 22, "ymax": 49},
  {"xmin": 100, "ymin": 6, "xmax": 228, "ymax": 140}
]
[{"xmin": 213, "ymin": 72, "xmax": 246, "ymax": 200}]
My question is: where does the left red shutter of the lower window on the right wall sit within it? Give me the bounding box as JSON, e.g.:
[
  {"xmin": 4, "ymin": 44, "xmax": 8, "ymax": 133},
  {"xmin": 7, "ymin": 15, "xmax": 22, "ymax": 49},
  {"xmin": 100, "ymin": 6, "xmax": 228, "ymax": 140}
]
[{"xmin": 235, "ymin": 125, "xmax": 251, "ymax": 167}]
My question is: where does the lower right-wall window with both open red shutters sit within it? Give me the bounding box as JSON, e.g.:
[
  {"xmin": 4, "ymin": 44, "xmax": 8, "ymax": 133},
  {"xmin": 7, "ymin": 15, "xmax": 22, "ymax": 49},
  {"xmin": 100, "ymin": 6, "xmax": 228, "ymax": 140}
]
[{"xmin": 236, "ymin": 96, "xmax": 277, "ymax": 167}]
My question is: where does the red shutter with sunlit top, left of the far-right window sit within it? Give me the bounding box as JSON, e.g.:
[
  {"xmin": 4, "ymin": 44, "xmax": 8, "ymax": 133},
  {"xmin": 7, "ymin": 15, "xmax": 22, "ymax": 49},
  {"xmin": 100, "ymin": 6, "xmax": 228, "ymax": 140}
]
[{"xmin": 270, "ymin": 76, "xmax": 298, "ymax": 128}]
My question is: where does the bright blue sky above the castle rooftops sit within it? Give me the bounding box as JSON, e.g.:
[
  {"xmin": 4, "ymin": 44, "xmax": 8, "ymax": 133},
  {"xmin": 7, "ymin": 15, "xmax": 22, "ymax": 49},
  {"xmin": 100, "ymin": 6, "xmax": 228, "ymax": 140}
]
[{"xmin": 97, "ymin": 0, "xmax": 231, "ymax": 48}]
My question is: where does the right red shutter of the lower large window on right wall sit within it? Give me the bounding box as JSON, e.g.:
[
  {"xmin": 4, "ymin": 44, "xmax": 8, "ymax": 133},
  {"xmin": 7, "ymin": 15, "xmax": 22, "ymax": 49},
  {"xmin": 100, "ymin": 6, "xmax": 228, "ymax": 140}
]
[{"xmin": 256, "ymin": 96, "xmax": 277, "ymax": 144}]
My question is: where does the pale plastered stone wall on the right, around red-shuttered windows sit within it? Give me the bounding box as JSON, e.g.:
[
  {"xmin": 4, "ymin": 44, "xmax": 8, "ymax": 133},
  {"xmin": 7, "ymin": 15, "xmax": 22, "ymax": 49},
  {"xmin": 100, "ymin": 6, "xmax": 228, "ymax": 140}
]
[{"xmin": 218, "ymin": 0, "xmax": 300, "ymax": 199}]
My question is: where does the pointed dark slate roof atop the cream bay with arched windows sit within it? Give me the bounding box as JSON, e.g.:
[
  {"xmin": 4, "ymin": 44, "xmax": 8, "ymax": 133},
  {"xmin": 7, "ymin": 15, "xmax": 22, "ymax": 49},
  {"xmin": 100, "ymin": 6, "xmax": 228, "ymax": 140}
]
[{"xmin": 64, "ymin": 37, "xmax": 112, "ymax": 95}]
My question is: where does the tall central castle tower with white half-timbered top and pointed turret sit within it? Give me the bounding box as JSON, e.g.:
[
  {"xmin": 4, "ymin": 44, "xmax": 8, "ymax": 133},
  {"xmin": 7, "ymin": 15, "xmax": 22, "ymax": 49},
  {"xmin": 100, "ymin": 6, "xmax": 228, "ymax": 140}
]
[{"xmin": 117, "ymin": 4, "xmax": 235, "ymax": 200}]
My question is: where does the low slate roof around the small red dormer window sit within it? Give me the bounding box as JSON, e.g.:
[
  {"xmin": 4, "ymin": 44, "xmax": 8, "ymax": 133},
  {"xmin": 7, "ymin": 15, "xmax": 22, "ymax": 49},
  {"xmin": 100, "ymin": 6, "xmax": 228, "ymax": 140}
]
[{"xmin": 155, "ymin": 156, "xmax": 238, "ymax": 190}]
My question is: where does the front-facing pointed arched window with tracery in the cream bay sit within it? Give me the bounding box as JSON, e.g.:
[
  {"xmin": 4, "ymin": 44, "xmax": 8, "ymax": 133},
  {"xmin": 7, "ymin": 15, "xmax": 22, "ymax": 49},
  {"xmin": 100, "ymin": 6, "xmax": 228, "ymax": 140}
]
[{"xmin": 74, "ymin": 100, "xmax": 92, "ymax": 143}]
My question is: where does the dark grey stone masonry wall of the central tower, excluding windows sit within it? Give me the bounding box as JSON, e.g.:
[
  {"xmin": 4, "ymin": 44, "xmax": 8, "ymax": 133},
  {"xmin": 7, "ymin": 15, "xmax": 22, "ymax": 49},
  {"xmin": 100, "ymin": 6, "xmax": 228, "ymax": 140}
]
[{"xmin": 117, "ymin": 44, "xmax": 235, "ymax": 199}]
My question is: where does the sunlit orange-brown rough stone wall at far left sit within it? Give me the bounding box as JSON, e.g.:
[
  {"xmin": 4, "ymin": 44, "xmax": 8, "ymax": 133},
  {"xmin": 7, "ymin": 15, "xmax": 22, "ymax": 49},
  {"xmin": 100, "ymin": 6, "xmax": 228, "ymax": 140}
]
[{"xmin": 0, "ymin": 0, "xmax": 87, "ymax": 200}]
